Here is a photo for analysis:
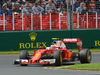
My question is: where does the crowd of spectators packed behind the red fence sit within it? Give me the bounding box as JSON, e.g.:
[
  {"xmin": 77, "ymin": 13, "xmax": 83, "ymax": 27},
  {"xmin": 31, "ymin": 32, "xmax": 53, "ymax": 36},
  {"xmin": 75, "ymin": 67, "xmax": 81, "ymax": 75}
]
[{"xmin": 0, "ymin": 0, "xmax": 100, "ymax": 15}]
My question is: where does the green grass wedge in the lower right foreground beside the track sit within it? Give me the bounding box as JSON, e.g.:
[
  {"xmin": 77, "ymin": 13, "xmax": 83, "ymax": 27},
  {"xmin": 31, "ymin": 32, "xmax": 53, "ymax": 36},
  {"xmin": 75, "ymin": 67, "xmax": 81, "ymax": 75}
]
[{"xmin": 57, "ymin": 63, "xmax": 100, "ymax": 71}]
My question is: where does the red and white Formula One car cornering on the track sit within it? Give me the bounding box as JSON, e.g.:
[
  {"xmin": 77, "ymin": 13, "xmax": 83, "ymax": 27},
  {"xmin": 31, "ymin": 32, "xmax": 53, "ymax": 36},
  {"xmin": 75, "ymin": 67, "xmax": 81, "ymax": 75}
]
[{"xmin": 14, "ymin": 39, "xmax": 91, "ymax": 66}]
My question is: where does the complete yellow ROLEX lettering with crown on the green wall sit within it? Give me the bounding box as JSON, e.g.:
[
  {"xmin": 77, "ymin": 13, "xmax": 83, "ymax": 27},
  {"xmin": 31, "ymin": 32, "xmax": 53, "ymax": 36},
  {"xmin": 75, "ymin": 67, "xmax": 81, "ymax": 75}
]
[{"xmin": 19, "ymin": 32, "xmax": 47, "ymax": 49}]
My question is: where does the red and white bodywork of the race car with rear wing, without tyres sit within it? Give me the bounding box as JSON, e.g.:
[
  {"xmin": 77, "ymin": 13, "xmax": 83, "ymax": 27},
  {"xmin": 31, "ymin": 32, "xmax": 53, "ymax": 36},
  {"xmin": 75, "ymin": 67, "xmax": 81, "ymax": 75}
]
[{"xmin": 21, "ymin": 39, "xmax": 82, "ymax": 64}]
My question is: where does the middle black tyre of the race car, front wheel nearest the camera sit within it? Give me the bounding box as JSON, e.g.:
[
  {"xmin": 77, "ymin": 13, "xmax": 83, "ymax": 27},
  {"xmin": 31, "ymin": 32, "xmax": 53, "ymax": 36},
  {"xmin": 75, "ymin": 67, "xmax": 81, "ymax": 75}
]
[{"xmin": 53, "ymin": 51, "xmax": 62, "ymax": 66}]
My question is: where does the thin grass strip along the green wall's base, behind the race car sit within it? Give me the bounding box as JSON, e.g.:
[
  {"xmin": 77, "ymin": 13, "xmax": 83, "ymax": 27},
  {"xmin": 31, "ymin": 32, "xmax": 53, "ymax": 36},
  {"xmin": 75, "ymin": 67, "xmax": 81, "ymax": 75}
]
[{"xmin": 0, "ymin": 48, "xmax": 100, "ymax": 55}]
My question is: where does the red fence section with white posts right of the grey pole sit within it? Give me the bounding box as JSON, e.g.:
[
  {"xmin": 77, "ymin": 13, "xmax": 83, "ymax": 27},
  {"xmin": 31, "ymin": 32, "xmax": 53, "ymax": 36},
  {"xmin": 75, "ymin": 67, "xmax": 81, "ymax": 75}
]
[{"xmin": 73, "ymin": 13, "xmax": 100, "ymax": 29}]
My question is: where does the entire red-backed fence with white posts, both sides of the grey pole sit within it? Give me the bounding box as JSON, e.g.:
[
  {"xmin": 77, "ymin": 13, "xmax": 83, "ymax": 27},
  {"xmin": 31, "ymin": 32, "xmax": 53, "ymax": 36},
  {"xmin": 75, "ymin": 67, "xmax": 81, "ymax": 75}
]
[{"xmin": 0, "ymin": 13, "xmax": 100, "ymax": 31}]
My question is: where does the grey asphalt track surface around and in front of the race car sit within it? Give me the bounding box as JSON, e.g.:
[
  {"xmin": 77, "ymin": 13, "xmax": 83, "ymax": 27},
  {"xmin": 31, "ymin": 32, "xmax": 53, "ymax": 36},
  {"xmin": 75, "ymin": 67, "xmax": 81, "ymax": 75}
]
[{"xmin": 0, "ymin": 53, "xmax": 100, "ymax": 75}]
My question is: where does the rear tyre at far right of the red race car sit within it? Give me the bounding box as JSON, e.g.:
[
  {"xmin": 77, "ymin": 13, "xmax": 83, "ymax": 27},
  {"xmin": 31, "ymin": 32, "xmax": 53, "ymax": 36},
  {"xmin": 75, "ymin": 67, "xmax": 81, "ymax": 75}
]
[{"xmin": 79, "ymin": 49, "xmax": 92, "ymax": 63}]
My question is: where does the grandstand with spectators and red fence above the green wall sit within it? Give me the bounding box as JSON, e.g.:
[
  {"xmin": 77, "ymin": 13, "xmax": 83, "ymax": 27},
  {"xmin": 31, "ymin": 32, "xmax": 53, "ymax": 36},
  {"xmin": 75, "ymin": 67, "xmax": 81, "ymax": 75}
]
[{"xmin": 0, "ymin": 0, "xmax": 100, "ymax": 31}]
